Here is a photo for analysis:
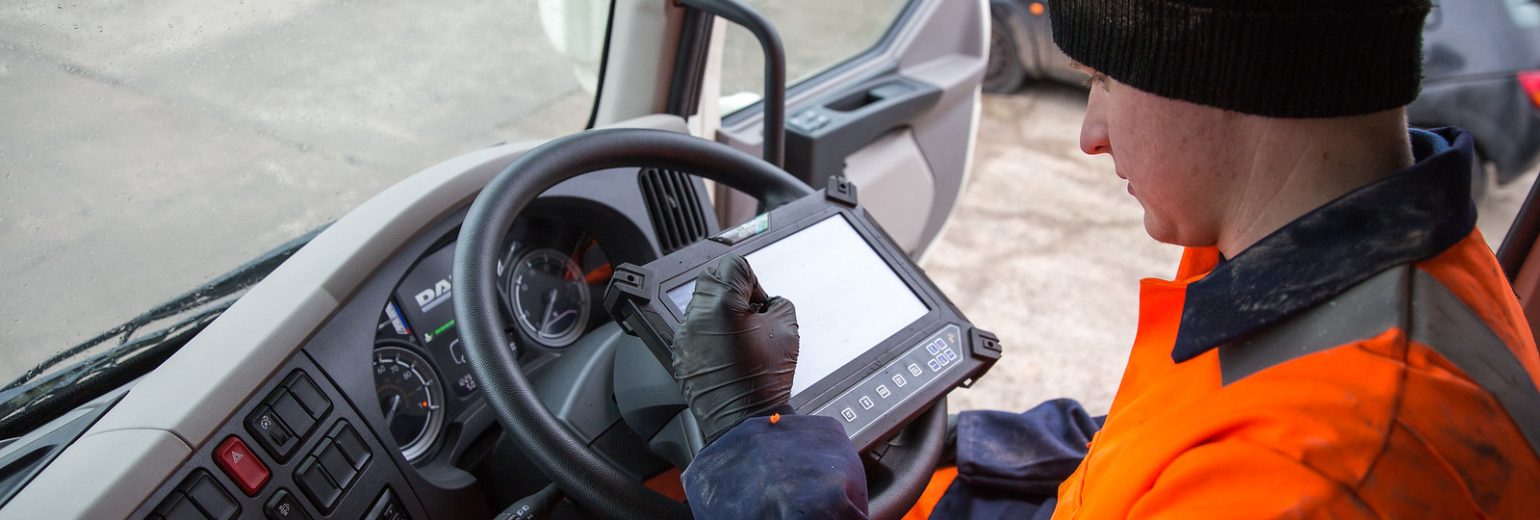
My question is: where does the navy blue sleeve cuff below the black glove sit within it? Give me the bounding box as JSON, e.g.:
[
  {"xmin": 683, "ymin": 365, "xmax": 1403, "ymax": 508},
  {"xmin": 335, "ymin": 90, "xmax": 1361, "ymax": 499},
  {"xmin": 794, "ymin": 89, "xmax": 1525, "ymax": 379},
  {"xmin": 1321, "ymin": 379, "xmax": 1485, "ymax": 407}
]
[{"xmin": 684, "ymin": 415, "xmax": 867, "ymax": 518}]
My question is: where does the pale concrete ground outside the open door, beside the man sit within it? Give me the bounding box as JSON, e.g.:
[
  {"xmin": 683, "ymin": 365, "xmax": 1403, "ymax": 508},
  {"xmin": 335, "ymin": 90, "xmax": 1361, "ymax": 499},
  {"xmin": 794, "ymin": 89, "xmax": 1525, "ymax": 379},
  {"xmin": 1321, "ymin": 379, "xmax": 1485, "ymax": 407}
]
[{"xmin": 924, "ymin": 85, "xmax": 1535, "ymax": 415}]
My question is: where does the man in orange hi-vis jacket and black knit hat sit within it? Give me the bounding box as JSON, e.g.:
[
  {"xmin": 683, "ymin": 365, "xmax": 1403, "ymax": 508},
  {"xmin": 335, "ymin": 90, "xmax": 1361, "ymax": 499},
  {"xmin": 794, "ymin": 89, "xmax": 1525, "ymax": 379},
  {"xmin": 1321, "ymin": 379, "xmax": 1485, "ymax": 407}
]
[{"xmin": 659, "ymin": 0, "xmax": 1540, "ymax": 518}]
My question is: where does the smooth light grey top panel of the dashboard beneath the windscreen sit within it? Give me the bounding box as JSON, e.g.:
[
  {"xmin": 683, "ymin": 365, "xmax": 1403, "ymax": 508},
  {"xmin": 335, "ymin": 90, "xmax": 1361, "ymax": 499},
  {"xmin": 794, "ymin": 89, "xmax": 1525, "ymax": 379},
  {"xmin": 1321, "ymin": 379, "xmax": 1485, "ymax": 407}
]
[{"xmin": 0, "ymin": 115, "xmax": 685, "ymax": 518}]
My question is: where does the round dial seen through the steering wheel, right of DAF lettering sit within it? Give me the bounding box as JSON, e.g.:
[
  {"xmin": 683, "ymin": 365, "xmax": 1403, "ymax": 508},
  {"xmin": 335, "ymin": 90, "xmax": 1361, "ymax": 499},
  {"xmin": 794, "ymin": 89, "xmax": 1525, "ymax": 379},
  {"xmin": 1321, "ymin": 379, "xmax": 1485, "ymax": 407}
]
[{"xmin": 510, "ymin": 249, "xmax": 588, "ymax": 348}]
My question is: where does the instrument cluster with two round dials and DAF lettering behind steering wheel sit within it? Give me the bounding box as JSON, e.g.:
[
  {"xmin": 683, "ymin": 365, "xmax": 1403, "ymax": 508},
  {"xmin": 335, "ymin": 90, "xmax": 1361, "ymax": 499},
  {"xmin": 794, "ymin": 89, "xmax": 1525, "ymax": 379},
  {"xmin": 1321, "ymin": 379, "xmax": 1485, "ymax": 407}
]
[{"xmin": 373, "ymin": 217, "xmax": 611, "ymax": 463}]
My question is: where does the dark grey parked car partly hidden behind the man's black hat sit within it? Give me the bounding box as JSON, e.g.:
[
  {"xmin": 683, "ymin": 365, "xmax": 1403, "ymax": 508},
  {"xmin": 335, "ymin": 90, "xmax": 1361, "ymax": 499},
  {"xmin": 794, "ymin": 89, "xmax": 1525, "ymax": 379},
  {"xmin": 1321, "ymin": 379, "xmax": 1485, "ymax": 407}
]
[{"xmin": 984, "ymin": 0, "xmax": 1540, "ymax": 186}]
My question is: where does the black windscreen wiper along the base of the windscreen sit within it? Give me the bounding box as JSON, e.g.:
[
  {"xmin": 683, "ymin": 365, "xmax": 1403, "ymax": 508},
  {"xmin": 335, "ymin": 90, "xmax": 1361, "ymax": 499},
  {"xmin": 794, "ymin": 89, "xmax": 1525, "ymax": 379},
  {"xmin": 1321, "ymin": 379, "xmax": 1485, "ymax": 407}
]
[{"xmin": 0, "ymin": 225, "xmax": 330, "ymax": 438}]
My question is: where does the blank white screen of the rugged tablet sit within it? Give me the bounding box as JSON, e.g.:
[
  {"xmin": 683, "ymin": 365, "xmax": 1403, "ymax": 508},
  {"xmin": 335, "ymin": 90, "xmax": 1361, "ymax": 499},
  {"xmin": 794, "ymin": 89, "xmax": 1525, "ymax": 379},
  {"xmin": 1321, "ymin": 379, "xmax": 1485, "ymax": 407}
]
[{"xmin": 668, "ymin": 215, "xmax": 930, "ymax": 395}]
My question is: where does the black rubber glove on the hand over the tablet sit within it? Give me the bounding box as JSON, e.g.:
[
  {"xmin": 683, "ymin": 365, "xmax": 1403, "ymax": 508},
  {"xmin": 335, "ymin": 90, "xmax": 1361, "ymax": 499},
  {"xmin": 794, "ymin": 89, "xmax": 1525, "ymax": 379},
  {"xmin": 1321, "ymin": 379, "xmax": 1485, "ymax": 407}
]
[{"xmin": 673, "ymin": 255, "xmax": 801, "ymax": 445}]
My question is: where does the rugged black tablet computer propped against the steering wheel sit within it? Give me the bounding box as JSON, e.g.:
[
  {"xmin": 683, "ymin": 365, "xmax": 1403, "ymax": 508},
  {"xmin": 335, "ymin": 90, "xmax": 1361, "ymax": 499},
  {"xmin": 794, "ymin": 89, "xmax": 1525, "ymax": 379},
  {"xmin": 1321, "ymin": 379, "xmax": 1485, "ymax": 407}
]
[{"xmin": 605, "ymin": 177, "xmax": 1001, "ymax": 449}]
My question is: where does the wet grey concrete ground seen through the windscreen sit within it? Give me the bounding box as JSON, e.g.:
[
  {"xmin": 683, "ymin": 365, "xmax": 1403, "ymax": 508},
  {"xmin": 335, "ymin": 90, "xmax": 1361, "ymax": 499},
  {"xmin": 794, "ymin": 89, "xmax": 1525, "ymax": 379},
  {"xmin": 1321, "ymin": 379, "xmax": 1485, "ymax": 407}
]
[{"xmin": 0, "ymin": 0, "xmax": 594, "ymax": 382}]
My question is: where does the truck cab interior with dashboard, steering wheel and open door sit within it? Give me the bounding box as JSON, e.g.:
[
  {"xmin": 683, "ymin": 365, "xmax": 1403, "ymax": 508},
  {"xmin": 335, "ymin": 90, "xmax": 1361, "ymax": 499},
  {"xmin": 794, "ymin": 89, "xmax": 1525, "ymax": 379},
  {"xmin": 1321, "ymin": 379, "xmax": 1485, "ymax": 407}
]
[{"xmin": 0, "ymin": 0, "xmax": 989, "ymax": 518}]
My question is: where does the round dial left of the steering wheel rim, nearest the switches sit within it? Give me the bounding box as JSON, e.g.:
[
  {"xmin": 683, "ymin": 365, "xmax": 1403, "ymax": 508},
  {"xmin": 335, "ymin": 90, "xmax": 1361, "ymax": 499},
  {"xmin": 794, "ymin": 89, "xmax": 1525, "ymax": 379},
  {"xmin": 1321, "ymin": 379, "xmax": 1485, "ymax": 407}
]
[{"xmin": 374, "ymin": 342, "xmax": 444, "ymax": 462}]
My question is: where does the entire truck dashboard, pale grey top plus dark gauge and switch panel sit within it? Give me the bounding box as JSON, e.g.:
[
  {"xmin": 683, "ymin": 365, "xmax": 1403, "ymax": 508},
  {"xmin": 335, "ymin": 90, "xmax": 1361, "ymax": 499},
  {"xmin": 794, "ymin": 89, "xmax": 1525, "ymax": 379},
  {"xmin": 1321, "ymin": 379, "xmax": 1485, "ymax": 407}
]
[{"xmin": 0, "ymin": 115, "xmax": 719, "ymax": 518}]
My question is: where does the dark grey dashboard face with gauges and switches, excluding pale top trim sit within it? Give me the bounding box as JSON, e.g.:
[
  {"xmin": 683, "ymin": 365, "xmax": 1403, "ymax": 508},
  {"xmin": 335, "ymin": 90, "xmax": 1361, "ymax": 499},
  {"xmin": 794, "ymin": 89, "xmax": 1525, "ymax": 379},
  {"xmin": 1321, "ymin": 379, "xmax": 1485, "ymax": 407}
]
[{"xmin": 124, "ymin": 176, "xmax": 705, "ymax": 520}]
